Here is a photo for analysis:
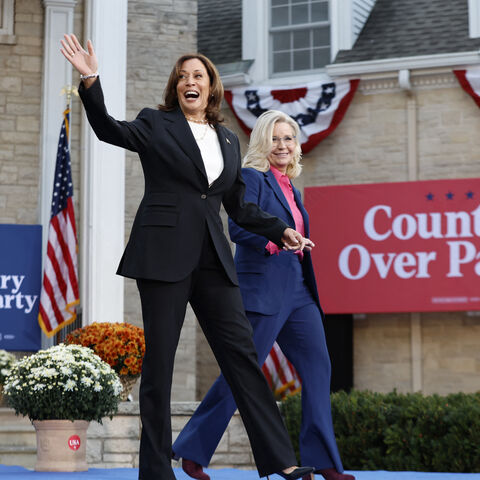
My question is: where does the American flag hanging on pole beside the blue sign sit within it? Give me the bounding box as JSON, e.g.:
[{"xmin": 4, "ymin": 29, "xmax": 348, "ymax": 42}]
[{"xmin": 38, "ymin": 108, "xmax": 79, "ymax": 337}]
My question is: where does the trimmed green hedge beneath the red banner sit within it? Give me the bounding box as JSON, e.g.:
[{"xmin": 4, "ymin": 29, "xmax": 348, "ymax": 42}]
[{"xmin": 281, "ymin": 391, "xmax": 480, "ymax": 473}]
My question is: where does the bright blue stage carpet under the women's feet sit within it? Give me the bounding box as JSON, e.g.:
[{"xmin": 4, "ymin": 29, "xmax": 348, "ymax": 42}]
[{"xmin": 0, "ymin": 465, "xmax": 480, "ymax": 480}]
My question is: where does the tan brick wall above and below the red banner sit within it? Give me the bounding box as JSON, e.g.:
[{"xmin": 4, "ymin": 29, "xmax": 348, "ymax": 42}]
[{"xmin": 302, "ymin": 84, "xmax": 480, "ymax": 394}]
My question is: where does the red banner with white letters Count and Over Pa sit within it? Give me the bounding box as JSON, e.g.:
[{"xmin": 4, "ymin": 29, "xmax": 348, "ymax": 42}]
[{"xmin": 305, "ymin": 178, "xmax": 480, "ymax": 313}]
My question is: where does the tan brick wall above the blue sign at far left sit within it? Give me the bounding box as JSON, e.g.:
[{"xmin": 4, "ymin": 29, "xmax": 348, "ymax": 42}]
[{"xmin": 0, "ymin": 0, "xmax": 44, "ymax": 224}]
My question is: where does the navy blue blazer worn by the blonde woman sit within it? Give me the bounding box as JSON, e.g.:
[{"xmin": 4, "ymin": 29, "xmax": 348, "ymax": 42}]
[{"xmin": 228, "ymin": 168, "xmax": 323, "ymax": 318}]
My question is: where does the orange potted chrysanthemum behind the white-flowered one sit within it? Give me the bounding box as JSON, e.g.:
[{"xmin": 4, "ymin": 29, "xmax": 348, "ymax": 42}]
[{"xmin": 65, "ymin": 322, "xmax": 145, "ymax": 400}]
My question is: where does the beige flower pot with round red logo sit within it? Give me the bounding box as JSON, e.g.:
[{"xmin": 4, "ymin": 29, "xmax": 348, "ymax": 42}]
[{"xmin": 33, "ymin": 420, "xmax": 89, "ymax": 472}]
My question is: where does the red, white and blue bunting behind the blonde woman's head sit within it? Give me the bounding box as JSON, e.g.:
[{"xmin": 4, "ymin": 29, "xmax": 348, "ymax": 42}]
[{"xmin": 225, "ymin": 80, "xmax": 359, "ymax": 153}]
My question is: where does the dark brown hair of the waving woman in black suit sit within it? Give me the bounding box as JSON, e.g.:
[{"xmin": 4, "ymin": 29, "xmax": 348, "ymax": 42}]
[{"xmin": 158, "ymin": 53, "xmax": 223, "ymax": 125}]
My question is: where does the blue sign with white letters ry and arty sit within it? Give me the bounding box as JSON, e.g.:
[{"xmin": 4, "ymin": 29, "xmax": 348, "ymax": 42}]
[{"xmin": 0, "ymin": 225, "xmax": 42, "ymax": 351}]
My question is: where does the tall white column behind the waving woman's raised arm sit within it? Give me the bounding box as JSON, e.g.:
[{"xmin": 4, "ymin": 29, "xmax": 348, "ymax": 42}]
[{"xmin": 80, "ymin": 0, "xmax": 128, "ymax": 325}]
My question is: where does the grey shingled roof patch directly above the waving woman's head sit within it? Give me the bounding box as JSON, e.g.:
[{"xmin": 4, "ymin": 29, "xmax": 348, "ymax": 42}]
[{"xmin": 198, "ymin": 0, "xmax": 242, "ymax": 64}]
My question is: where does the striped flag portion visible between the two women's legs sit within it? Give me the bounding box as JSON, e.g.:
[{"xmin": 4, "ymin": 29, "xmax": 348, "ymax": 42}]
[{"xmin": 262, "ymin": 342, "xmax": 302, "ymax": 400}]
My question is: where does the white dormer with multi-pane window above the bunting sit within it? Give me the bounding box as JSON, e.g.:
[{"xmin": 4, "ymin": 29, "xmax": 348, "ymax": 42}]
[{"xmin": 242, "ymin": 0, "xmax": 376, "ymax": 83}]
